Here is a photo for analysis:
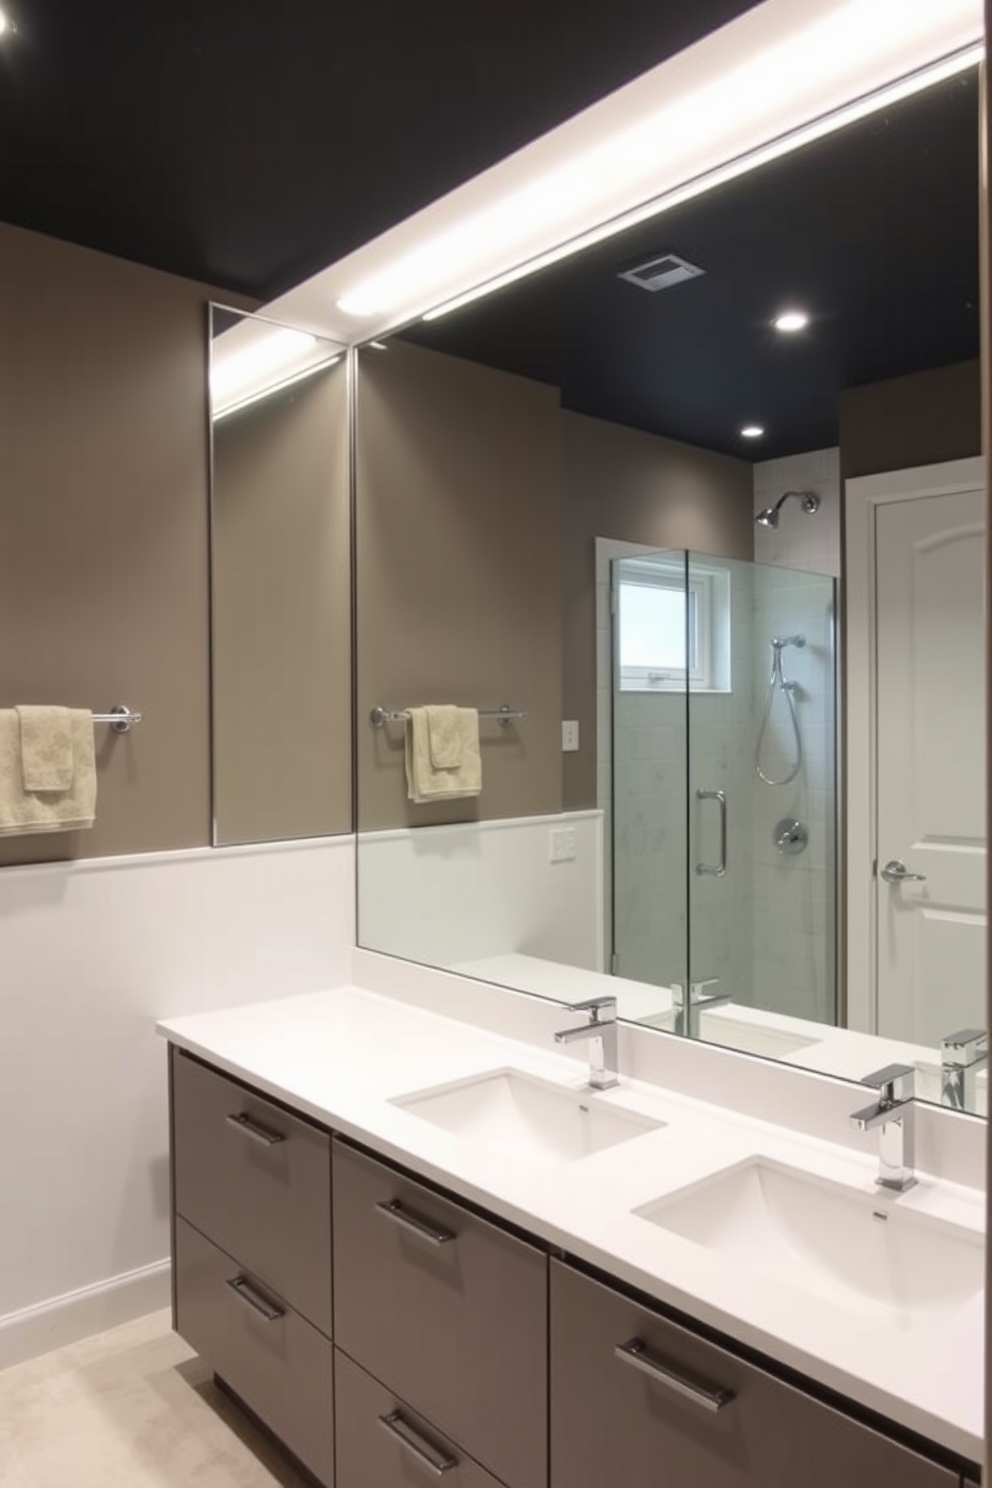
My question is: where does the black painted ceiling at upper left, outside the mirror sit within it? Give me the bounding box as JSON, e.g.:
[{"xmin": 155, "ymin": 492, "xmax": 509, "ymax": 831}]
[{"xmin": 0, "ymin": 0, "xmax": 754, "ymax": 299}]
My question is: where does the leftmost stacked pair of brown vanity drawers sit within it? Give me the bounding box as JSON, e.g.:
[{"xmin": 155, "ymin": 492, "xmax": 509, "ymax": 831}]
[{"xmin": 171, "ymin": 1049, "xmax": 335, "ymax": 1488}]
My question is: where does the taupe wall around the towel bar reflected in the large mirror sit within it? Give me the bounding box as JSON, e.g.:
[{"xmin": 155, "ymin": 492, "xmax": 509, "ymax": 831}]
[{"xmin": 355, "ymin": 342, "xmax": 562, "ymax": 830}]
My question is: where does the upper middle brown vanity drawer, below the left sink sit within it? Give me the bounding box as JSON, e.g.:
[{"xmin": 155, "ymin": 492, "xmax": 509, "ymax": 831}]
[{"xmin": 333, "ymin": 1141, "xmax": 547, "ymax": 1488}]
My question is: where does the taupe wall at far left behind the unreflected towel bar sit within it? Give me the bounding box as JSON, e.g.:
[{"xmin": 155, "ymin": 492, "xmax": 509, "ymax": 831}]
[{"xmin": 0, "ymin": 226, "xmax": 246, "ymax": 865}]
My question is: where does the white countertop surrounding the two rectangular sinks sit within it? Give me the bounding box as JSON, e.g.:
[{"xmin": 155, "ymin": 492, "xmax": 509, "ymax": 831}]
[{"xmin": 158, "ymin": 987, "xmax": 985, "ymax": 1463}]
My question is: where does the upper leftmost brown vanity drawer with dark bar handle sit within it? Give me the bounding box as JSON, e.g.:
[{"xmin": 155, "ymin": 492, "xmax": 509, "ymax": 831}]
[{"xmin": 173, "ymin": 1051, "xmax": 332, "ymax": 1336}]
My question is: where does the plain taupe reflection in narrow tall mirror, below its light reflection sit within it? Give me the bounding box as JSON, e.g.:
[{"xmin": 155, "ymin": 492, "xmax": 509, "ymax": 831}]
[{"xmin": 213, "ymin": 360, "xmax": 351, "ymax": 842}]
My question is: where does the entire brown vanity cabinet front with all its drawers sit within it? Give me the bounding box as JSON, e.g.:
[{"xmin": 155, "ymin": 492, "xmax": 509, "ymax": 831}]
[{"xmin": 171, "ymin": 1049, "xmax": 977, "ymax": 1488}]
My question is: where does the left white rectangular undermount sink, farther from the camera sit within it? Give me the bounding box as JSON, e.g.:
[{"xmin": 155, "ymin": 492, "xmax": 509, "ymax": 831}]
[{"xmin": 393, "ymin": 1070, "xmax": 665, "ymax": 1167}]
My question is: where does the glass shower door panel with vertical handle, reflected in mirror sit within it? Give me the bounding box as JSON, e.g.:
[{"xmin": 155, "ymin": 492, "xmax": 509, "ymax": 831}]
[{"xmin": 683, "ymin": 554, "xmax": 837, "ymax": 1058}]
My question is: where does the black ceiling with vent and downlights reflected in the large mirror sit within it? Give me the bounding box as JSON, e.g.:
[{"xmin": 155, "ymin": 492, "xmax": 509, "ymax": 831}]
[{"xmin": 405, "ymin": 73, "xmax": 979, "ymax": 460}]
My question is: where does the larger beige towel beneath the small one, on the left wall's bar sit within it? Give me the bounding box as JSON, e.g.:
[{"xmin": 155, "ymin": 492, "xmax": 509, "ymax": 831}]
[{"xmin": 0, "ymin": 708, "xmax": 97, "ymax": 838}]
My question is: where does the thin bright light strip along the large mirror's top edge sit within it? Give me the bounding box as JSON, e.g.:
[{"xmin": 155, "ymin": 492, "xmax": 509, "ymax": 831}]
[{"xmin": 425, "ymin": 45, "xmax": 985, "ymax": 320}]
